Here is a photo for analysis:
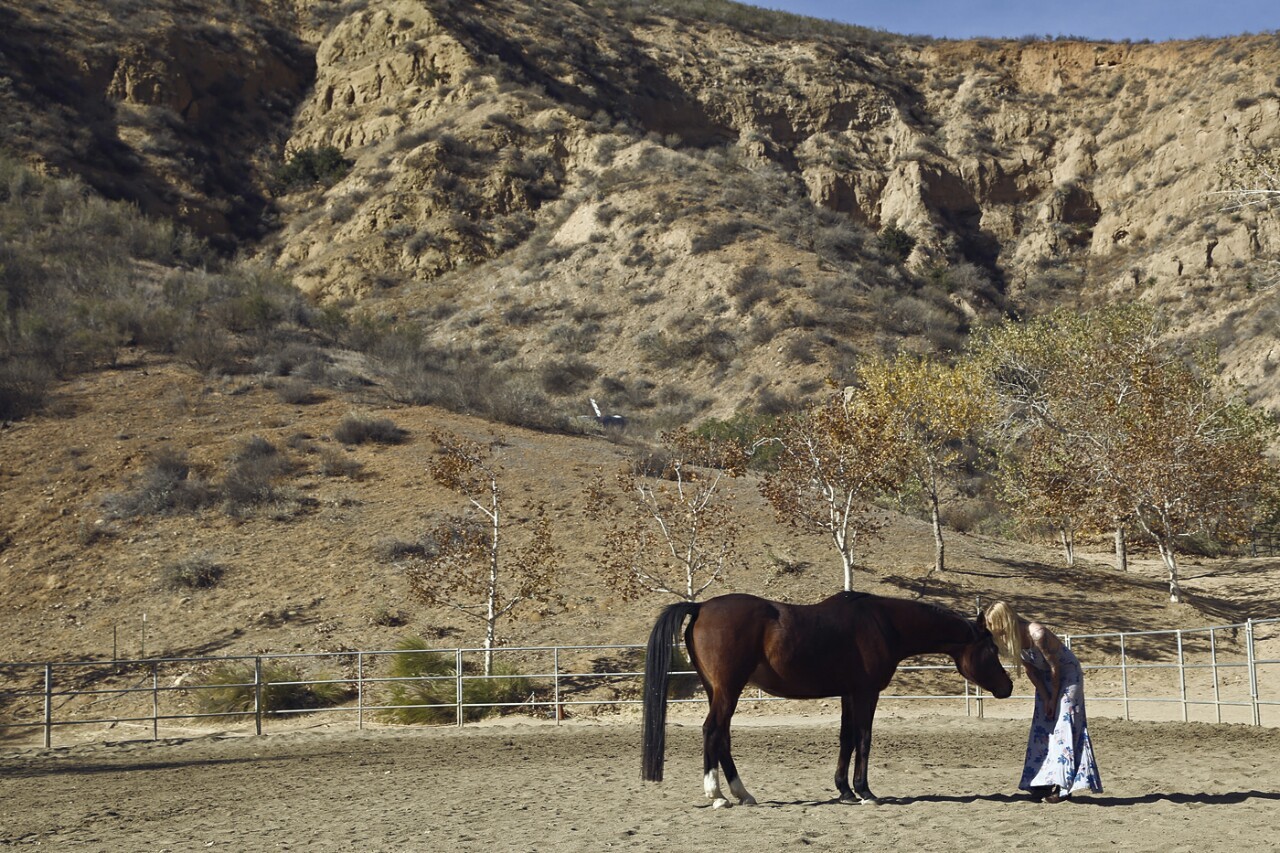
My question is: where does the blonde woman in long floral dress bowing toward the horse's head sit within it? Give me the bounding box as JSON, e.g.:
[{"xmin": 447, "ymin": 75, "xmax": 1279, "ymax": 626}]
[{"xmin": 987, "ymin": 601, "xmax": 1102, "ymax": 803}]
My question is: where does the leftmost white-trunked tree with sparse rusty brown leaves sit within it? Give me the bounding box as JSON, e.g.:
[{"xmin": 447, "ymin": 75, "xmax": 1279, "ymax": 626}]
[{"xmin": 407, "ymin": 432, "xmax": 561, "ymax": 675}]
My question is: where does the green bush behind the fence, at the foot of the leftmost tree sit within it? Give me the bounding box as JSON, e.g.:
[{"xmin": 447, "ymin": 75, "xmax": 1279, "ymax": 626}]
[{"xmin": 381, "ymin": 637, "xmax": 532, "ymax": 725}]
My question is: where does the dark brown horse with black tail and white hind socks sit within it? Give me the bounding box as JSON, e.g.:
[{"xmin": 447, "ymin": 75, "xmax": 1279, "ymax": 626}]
[{"xmin": 643, "ymin": 592, "xmax": 1014, "ymax": 808}]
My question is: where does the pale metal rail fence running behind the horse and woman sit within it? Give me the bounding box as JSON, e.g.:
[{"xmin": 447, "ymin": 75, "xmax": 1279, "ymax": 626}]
[{"xmin": 0, "ymin": 619, "xmax": 1280, "ymax": 747}]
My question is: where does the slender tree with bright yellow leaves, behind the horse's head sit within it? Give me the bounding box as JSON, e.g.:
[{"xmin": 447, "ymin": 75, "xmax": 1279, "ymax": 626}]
[{"xmin": 855, "ymin": 355, "xmax": 992, "ymax": 571}]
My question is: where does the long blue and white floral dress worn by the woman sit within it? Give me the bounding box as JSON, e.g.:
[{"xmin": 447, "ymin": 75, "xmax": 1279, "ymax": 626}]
[{"xmin": 1018, "ymin": 635, "xmax": 1102, "ymax": 795}]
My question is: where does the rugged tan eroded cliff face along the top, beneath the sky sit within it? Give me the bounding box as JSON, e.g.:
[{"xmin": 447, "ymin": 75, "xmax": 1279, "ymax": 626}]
[{"xmin": 0, "ymin": 0, "xmax": 1280, "ymax": 411}]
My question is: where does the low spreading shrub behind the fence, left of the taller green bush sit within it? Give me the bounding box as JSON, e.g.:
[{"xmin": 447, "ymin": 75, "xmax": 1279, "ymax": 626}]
[{"xmin": 193, "ymin": 661, "xmax": 352, "ymax": 717}]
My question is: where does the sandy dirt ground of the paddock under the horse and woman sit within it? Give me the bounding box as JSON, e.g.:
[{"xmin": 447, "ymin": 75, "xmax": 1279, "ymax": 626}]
[{"xmin": 0, "ymin": 713, "xmax": 1280, "ymax": 853}]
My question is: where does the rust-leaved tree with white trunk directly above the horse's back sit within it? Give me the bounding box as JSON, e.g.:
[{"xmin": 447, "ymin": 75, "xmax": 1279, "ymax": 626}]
[{"xmin": 760, "ymin": 389, "xmax": 911, "ymax": 590}]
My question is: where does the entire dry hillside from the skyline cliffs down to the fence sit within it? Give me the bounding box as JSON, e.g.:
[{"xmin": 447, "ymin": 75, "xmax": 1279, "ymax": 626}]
[{"xmin": 0, "ymin": 0, "xmax": 1280, "ymax": 660}]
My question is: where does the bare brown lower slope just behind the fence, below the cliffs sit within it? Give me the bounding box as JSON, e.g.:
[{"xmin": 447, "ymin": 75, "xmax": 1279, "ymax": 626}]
[{"xmin": 0, "ymin": 357, "xmax": 1280, "ymax": 660}]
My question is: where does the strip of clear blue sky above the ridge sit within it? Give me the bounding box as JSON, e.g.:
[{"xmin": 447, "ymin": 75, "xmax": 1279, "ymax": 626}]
[{"xmin": 746, "ymin": 0, "xmax": 1280, "ymax": 41}]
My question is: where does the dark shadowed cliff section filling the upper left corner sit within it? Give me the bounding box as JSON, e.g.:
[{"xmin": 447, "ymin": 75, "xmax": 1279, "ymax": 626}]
[{"xmin": 0, "ymin": 0, "xmax": 314, "ymax": 239}]
